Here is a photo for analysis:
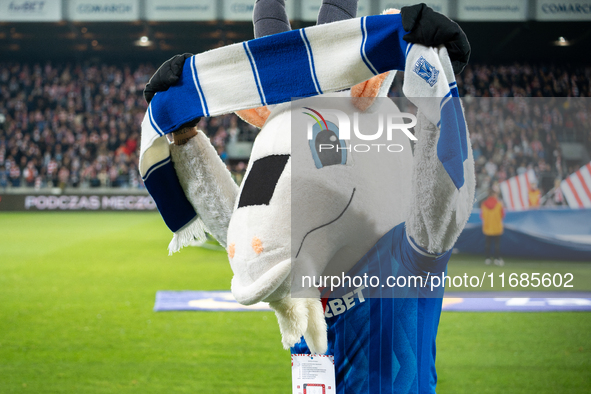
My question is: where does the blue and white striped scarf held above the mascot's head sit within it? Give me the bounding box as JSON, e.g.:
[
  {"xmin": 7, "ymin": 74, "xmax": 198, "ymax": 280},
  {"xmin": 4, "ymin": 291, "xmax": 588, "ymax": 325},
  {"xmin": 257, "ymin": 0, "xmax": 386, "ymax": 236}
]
[{"xmin": 140, "ymin": 14, "xmax": 466, "ymax": 251}]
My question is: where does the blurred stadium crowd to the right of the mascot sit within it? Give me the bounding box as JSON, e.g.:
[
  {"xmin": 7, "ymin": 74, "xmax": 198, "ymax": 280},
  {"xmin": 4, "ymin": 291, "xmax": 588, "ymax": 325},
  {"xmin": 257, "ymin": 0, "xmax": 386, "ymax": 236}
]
[{"xmin": 458, "ymin": 64, "xmax": 591, "ymax": 203}]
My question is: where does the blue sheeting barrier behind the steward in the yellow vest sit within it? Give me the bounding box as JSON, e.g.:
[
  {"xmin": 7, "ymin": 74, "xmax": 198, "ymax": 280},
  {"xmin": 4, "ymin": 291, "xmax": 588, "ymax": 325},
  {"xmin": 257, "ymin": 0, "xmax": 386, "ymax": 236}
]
[{"xmin": 455, "ymin": 209, "xmax": 591, "ymax": 262}]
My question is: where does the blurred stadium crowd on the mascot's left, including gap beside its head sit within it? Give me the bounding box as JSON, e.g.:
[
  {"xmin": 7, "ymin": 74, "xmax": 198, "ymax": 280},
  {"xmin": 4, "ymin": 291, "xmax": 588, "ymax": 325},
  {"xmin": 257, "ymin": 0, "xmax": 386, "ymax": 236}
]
[{"xmin": 0, "ymin": 63, "xmax": 256, "ymax": 189}]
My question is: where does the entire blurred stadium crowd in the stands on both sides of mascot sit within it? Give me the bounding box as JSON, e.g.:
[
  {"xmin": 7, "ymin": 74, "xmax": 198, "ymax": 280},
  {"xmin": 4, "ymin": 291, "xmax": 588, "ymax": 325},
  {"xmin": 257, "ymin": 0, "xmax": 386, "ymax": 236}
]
[{"xmin": 0, "ymin": 63, "xmax": 591, "ymax": 202}]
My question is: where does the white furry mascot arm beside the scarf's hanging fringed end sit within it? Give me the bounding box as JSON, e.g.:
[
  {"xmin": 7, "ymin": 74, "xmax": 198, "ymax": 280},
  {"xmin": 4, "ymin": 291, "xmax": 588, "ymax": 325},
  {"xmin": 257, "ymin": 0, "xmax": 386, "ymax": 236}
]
[{"xmin": 170, "ymin": 129, "xmax": 238, "ymax": 247}]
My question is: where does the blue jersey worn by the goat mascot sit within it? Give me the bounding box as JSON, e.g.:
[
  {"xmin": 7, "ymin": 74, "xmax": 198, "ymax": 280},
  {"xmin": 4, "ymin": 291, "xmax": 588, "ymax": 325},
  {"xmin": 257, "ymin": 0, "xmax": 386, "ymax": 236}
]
[{"xmin": 291, "ymin": 223, "xmax": 451, "ymax": 394}]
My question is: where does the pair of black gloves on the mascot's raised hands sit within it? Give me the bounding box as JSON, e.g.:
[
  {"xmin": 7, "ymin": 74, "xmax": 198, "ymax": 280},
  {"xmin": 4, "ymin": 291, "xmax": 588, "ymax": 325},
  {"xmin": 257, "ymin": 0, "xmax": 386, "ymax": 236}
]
[{"xmin": 144, "ymin": 3, "xmax": 470, "ymax": 95}]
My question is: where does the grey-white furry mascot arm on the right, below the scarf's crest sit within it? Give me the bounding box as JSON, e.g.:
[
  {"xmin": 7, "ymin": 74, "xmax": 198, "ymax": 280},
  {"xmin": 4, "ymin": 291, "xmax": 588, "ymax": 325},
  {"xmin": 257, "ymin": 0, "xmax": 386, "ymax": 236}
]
[{"xmin": 406, "ymin": 111, "xmax": 476, "ymax": 254}]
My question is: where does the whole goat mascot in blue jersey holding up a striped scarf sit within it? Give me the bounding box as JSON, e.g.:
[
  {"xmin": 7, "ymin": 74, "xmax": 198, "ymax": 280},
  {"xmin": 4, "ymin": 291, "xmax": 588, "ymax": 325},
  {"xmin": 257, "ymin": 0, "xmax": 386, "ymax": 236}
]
[{"xmin": 140, "ymin": 0, "xmax": 475, "ymax": 394}]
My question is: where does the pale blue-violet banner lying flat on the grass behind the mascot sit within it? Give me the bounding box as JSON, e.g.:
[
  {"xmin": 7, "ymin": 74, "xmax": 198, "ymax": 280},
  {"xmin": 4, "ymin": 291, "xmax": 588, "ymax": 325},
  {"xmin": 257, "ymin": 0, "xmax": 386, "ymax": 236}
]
[{"xmin": 154, "ymin": 291, "xmax": 591, "ymax": 312}]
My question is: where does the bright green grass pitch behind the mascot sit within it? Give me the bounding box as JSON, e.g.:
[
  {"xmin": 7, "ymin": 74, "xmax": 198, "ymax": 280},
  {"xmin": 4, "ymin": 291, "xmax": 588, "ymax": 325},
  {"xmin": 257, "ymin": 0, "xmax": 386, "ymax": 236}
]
[{"xmin": 0, "ymin": 213, "xmax": 591, "ymax": 394}]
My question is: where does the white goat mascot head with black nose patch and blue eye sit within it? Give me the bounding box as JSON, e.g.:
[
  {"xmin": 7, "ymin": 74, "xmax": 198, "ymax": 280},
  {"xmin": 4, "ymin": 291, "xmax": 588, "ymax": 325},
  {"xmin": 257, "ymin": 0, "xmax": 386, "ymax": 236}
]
[{"xmin": 228, "ymin": 84, "xmax": 412, "ymax": 304}]
